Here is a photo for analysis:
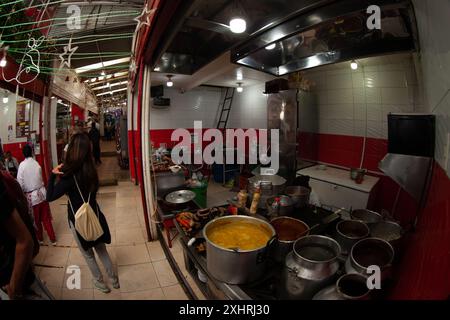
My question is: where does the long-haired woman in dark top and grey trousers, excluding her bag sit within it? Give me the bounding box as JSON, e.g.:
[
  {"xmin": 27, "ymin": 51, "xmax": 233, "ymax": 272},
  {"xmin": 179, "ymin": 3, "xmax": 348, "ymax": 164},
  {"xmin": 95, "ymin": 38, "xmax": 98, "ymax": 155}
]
[{"xmin": 47, "ymin": 133, "xmax": 120, "ymax": 293}]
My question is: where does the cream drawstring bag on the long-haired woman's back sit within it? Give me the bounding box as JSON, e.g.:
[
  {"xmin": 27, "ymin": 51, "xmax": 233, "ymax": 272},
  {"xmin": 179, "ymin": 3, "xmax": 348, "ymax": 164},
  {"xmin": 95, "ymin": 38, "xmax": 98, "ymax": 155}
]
[{"xmin": 69, "ymin": 176, "xmax": 103, "ymax": 241}]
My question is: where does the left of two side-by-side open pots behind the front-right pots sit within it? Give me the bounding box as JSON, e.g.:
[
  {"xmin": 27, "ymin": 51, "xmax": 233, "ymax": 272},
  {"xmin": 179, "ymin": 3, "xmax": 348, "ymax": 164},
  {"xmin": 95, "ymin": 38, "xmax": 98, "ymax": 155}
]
[{"xmin": 335, "ymin": 220, "xmax": 370, "ymax": 255}]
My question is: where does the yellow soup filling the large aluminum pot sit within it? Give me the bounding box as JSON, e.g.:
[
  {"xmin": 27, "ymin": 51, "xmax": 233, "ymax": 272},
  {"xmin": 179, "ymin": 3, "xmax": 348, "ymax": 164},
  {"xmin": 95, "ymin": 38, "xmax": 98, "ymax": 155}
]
[{"xmin": 207, "ymin": 221, "xmax": 271, "ymax": 250}]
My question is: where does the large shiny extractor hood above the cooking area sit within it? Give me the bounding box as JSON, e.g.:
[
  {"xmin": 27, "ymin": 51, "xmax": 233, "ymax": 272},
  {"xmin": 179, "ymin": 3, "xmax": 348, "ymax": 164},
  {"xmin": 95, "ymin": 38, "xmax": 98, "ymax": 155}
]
[{"xmin": 231, "ymin": 0, "xmax": 417, "ymax": 76}]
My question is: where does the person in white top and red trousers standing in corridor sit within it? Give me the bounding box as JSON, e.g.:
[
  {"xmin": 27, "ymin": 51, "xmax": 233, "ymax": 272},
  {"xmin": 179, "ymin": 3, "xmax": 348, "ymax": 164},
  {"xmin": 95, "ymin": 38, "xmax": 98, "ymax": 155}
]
[{"xmin": 17, "ymin": 144, "xmax": 56, "ymax": 246}]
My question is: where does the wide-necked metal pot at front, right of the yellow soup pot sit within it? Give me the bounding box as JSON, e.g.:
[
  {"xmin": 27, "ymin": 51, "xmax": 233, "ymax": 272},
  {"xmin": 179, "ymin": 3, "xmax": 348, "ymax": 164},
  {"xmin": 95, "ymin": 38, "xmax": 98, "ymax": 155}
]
[{"xmin": 278, "ymin": 235, "xmax": 341, "ymax": 300}]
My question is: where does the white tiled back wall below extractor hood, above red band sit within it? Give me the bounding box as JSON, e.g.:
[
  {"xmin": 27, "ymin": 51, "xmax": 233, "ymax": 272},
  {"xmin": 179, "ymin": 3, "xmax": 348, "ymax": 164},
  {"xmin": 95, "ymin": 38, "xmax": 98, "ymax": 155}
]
[{"xmin": 300, "ymin": 54, "xmax": 423, "ymax": 139}]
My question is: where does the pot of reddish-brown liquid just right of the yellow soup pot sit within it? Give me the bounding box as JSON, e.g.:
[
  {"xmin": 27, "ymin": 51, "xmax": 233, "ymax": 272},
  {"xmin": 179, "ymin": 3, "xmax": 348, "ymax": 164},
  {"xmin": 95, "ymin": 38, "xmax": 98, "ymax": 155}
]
[{"xmin": 270, "ymin": 217, "xmax": 309, "ymax": 263}]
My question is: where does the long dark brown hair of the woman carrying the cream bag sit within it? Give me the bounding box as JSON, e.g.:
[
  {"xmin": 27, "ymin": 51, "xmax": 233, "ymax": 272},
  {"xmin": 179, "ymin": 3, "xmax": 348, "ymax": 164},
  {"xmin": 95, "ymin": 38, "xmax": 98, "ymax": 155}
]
[{"xmin": 62, "ymin": 133, "xmax": 98, "ymax": 194}]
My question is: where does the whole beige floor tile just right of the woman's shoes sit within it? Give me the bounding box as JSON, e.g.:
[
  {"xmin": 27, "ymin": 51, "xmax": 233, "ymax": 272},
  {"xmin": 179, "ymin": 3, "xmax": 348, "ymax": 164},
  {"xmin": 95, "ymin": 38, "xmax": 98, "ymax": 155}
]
[{"xmin": 119, "ymin": 263, "xmax": 160, "ymax": 293}]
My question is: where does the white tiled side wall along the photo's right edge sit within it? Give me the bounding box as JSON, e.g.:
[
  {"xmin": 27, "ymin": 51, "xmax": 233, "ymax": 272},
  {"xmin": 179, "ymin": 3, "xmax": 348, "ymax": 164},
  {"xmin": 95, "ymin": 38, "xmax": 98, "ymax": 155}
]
[{"xmin": 414, "ymin": 0, "xmax": 450, "ymax": 176}]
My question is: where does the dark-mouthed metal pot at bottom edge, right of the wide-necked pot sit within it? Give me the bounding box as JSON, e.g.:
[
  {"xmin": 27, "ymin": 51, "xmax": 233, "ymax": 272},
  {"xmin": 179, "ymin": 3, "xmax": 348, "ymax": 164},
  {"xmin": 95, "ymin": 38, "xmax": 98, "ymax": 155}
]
[{"xmin": 313, "ymin": 274, "xmax": 370, "ymax": 300}]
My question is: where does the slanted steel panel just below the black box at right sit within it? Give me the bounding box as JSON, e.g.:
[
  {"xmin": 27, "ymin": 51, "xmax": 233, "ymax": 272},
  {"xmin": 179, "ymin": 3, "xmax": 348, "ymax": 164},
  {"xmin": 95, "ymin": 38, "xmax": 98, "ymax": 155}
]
[{"xmin": 379, "ymin": 153, "xmax": 433, "ymax": 202}]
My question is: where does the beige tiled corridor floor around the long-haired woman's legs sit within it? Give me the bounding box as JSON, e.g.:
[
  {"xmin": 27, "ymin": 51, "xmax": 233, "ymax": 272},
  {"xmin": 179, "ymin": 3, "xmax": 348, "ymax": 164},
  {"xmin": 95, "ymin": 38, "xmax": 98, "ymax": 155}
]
[{"xmin": 31, "ymin": 181, "xmax": 187, "ymax": 300}]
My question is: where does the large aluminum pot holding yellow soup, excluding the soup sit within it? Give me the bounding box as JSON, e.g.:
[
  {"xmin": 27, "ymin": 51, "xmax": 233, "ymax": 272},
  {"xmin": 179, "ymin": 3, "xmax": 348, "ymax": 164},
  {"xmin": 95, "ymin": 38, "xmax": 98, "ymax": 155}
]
[{"xmin": 203, "ymin": 215, "xmax": 275, "ymax": 284}]
